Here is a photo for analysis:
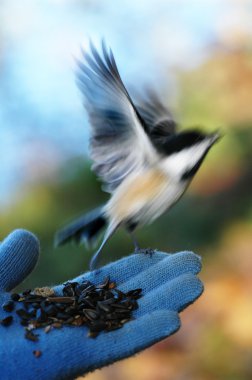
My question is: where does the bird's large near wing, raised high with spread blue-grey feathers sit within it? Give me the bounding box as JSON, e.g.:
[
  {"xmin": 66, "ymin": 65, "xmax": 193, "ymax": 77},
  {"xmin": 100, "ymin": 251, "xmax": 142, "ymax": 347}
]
[{"xmin": 77, "ymin": 42, "xmax": 157, "ymax": 192}]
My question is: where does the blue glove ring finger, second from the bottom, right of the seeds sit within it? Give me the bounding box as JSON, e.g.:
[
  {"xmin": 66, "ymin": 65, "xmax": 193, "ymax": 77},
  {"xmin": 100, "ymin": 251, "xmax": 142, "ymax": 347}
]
[{"xmin": 134, "ymin": 273, "xmax": 204, "ymax": 317}]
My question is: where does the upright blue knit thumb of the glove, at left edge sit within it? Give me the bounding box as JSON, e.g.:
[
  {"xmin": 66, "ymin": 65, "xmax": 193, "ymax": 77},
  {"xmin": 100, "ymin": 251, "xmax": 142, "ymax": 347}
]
[{"xmin": 0, "ymin": 229, "xmax": 39, "ymax": 291}]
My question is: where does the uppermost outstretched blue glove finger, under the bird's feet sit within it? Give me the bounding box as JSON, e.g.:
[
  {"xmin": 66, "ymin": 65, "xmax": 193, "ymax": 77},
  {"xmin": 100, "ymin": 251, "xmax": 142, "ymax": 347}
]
[{"xmin": 54, "ymin": 252, "xmax": 167, "ymax": 293}]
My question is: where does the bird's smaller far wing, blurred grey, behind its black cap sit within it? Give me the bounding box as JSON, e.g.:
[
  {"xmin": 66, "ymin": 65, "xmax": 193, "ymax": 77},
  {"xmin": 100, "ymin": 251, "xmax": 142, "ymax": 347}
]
[{"xmin": 137, "ymin": 89, "xmax": 177, "ymax": 150}]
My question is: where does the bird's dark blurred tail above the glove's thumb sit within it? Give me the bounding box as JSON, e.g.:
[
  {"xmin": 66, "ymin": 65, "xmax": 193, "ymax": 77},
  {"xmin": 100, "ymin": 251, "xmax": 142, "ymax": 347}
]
[{"xmin": 54, "ymin": 206, "xmax": 107, "ymax": 246}]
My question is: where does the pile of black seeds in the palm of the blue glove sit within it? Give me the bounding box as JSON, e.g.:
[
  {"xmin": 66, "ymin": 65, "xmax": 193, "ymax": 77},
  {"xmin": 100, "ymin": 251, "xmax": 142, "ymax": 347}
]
[{"xmin": 5, "ymin": 277, "xmax": 141, "ymax": 341}]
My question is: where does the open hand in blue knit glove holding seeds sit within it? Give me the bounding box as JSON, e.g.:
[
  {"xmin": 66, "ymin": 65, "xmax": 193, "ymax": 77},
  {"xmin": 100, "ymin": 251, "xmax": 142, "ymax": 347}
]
[{"xmin": 0, "ymin": 230, "xmax": 203, "ymax": 380}]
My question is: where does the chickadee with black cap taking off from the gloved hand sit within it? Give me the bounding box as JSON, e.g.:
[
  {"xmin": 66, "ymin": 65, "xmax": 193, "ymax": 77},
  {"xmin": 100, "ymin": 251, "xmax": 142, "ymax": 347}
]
[{"xmin": 55, "ymin": 42, "xmax": 219, "ymax": 270}]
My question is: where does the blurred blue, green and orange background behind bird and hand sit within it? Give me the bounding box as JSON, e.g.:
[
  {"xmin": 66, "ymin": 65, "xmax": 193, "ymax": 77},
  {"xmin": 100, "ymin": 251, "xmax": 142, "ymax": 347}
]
[{"xmin": 0, "ymin": 0, "xmax": 252, "ymax": 380}]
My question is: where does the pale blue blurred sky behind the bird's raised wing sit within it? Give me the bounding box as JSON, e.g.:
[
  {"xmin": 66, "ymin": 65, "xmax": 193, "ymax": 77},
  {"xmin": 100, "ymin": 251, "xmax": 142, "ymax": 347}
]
[{"xmin": 0, "ymin": 0, "xmax": 252, "ymax": 207}]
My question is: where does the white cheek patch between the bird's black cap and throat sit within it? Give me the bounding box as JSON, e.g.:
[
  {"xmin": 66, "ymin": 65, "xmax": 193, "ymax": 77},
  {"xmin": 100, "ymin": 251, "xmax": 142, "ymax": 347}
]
[{"xmin": 161, "ymin": 139, "xmax": 211, "ymax": 177}]
